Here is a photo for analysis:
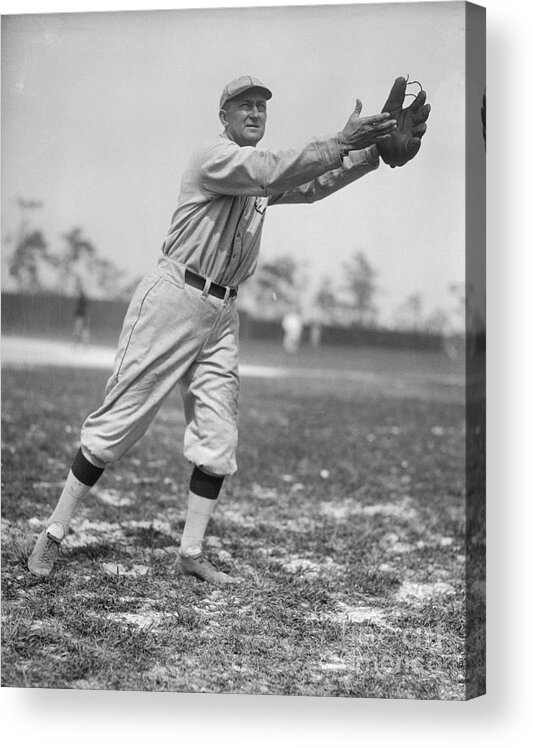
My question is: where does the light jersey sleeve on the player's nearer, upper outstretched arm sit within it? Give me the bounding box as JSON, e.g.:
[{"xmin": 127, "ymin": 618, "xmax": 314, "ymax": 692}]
[{"xmin": 200, "ymin": 136, "xmax": 342, "ymax": 197}]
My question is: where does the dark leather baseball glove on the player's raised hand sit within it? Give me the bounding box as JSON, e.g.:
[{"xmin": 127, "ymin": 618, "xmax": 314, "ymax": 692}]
[{"xmin": 376, "ymin": 78, "xmax": 431, "ymax": 169}]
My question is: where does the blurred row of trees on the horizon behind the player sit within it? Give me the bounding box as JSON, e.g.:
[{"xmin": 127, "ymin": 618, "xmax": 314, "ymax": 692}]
[{"xmin": 4, "ymin": 198, "xmax": 465, "ymax": 333}]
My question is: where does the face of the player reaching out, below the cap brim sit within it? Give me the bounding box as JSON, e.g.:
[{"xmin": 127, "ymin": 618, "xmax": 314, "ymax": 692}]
[{"xmin": 220, "ymin": 88, "xmax": 266, "ymax": 148}]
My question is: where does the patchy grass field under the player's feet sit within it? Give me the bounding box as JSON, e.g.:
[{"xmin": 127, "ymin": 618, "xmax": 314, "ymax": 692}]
[{"xmin": 2, "ymin": 346, "xmax": 465, "ymax": 699}]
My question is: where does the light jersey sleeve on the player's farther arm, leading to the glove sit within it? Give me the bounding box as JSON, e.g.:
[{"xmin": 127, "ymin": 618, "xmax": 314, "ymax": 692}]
[{"xmin": 268, "ymin": 146, "xmax": 379, "ymax": 206}]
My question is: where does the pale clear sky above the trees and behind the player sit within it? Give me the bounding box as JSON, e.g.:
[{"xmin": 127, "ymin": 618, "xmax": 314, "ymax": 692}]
[{"xmin": 2, "ymin": 2, "xmax": 474, "ymax": 323}]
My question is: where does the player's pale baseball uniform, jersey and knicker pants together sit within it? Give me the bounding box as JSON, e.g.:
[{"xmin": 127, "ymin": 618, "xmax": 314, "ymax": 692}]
[{"xmin": 81, "ymin": 135, "xmax": 379, "ymax": 475}]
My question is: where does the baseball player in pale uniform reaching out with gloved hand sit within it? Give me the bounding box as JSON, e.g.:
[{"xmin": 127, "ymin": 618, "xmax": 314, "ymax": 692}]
[{"xmin": 28, "ymin": 76, "xmax": 429, "ymax": 584}]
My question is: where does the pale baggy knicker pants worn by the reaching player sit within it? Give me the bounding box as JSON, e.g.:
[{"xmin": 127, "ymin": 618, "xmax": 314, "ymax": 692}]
[{"xmin": 81, "ymin": 257, "xmax": 239, "ymax": 475}]
